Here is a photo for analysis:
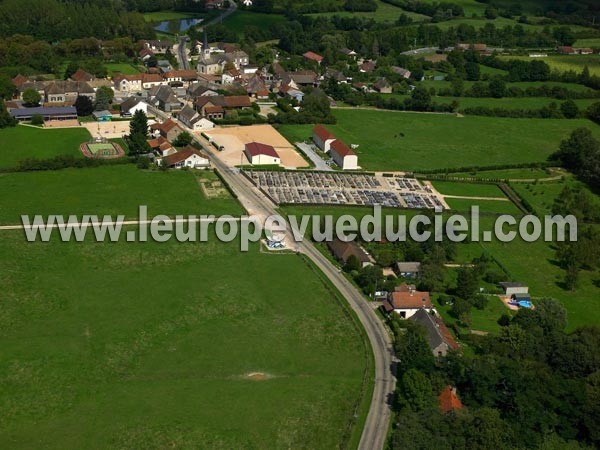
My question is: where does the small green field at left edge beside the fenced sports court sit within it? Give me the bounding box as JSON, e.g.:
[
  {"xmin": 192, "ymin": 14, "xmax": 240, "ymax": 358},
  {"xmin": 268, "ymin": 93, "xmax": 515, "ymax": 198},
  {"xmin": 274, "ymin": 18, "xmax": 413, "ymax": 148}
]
[{"xmin": 0, "ymin": 125, "xmax": 90, "ymax": 167}]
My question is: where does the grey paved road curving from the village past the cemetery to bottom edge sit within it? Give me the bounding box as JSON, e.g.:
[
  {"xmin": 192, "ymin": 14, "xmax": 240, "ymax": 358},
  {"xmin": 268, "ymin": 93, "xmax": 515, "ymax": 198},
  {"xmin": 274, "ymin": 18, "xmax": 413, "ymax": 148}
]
[{"xmin": 198, "ymin": 134, "xmax": 396, "ymax": 450}]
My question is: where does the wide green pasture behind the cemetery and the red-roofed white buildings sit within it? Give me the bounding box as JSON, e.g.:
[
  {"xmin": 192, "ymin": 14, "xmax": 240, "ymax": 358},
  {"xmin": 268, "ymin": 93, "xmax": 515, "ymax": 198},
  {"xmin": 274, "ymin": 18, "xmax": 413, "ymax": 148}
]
[{"xmin": 280, "ymin": 109, "xmax": 600, "ymax": 170}]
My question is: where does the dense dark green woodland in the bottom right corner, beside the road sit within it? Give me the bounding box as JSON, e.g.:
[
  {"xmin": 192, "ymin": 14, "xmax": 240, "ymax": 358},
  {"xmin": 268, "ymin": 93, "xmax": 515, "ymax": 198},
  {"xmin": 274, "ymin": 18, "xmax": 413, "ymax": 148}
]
[{"xmin": 390, "ymin": 299, "xmax": 600, "ymax": 450}]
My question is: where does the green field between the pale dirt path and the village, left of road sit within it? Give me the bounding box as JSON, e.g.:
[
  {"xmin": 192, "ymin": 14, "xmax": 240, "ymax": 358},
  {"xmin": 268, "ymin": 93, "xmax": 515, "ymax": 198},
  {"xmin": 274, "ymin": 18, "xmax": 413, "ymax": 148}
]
[{"xmin": 0, "ymin": 165, "xmax": 242, "ymax": 225}]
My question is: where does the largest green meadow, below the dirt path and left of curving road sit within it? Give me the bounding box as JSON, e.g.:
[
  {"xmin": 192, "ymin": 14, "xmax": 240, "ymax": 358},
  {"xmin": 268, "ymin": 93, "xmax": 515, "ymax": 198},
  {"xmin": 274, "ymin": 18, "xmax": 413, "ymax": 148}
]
[{"xmin": 0, "ymin": 232, "xmax": 371, "ymax": 450}]
